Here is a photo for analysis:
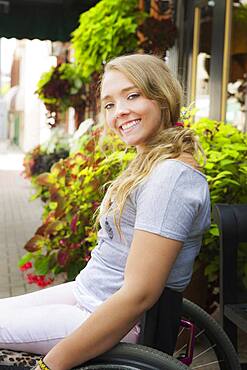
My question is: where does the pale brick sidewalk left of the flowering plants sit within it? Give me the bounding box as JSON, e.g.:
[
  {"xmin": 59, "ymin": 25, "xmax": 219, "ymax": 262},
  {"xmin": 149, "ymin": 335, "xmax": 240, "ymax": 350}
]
[{"xmin": 0, "ymin": 143, "xmax": 42, "ymax": 298}]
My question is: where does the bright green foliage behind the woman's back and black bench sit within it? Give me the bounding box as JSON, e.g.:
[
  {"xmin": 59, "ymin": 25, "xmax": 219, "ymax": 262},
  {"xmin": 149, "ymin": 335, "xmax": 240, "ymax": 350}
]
[{"xmin": 192, "ymin": 119, "xmax": 247, "ymax": 286}]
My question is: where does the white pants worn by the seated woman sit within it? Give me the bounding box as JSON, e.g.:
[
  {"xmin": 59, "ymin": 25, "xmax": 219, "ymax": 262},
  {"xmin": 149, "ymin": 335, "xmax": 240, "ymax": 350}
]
[{"xmin": 0, "ymin": 282, "xmax": 139, "ymax": 354}]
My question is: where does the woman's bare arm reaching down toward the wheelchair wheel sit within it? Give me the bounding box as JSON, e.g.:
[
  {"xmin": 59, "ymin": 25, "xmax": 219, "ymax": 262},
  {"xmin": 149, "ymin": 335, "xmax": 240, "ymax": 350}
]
[{"xmin": 38, "ymin": 230, "xmax": 182, "ymax": 370}]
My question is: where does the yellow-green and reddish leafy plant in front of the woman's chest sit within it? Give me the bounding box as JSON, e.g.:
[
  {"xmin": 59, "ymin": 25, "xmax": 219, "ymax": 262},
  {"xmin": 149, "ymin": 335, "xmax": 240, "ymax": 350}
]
[{"xmin": 19, "ymin": 128, "xmax": 135, "ymax": 285}]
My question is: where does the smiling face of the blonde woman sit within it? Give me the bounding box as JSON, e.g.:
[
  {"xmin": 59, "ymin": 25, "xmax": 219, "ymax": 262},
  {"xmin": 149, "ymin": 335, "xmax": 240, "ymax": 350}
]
[{"xmin": 101, "ymin": 70, "xmax": 162, "ymax": 150}]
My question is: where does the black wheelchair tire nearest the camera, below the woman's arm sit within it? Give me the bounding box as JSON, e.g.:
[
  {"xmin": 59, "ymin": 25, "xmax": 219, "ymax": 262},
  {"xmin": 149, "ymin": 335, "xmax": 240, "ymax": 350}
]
[{"xmin": 76, "ymin": 343, "xmax": 188, "ymax": 370}]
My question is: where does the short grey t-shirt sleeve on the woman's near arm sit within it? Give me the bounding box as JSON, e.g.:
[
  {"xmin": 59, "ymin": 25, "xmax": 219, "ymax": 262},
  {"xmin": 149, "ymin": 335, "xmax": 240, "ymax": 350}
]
[{"xmin": 135, "ymin": 160, "xmax": 207, "ymax": 242}]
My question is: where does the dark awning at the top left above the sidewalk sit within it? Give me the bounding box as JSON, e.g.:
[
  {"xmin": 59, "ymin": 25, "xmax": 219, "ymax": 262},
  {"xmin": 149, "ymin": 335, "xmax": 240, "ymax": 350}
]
[{"xmin": 0, "ymin": 0, "xmax": 99, "ymax": 41}]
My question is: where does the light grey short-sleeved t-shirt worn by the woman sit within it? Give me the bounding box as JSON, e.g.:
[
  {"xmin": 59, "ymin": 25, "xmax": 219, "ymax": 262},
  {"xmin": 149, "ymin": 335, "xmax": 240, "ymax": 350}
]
[{"xmin": 74, "ymin": 159, "xmax": 210, "ymax": 312}]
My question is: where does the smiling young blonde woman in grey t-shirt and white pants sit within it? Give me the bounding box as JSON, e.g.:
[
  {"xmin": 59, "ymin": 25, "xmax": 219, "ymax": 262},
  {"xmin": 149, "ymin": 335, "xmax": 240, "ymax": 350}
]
[{"xmin": 0, "ymin": 54, "xmax": 210, "ymax": 370}]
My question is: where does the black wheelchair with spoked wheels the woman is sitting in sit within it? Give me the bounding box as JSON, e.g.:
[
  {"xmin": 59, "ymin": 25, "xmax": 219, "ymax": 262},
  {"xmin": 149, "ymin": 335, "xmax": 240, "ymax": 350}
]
[{"xmin": 80, "ymin": 288, "xmax": 241, "ymax": 370}]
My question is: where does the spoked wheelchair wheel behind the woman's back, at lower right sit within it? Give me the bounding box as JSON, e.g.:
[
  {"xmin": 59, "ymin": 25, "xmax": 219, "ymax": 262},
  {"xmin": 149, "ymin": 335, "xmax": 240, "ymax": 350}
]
[{"xmin": 174, "ymin": 299, "xmax": 241, "ymax": 370}]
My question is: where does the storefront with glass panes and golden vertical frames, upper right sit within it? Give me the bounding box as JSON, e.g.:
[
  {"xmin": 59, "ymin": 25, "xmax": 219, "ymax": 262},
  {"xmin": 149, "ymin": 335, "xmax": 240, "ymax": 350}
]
[{"xmin": 174, "ymin": 0, "xmax": 247, "ymax": 131}]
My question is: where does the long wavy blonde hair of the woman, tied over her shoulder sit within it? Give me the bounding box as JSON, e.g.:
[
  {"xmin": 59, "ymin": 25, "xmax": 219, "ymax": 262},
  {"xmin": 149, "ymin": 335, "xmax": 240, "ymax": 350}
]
[{"xmin": 97, "ymin": 54, "xmax": 202, "ymax": 234}]
